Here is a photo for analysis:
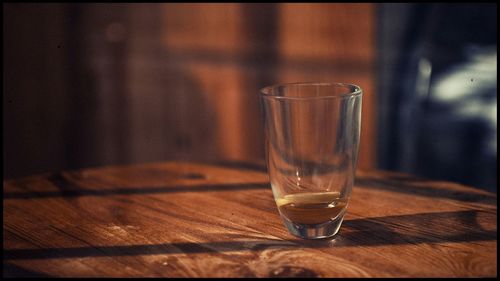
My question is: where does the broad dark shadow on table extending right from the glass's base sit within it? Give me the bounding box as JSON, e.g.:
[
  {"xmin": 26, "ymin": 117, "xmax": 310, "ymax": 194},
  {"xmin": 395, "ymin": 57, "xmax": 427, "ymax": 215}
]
[{"xmin": 335, "ymin": 211, "xmax": 496, "ymax": 247}]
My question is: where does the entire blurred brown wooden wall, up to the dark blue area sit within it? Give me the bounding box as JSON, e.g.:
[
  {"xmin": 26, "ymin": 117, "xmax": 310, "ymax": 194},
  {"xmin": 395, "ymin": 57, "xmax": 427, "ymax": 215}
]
[{"xmin": 4, "ymin": 3, "xmax": 376, "ymax": 176}]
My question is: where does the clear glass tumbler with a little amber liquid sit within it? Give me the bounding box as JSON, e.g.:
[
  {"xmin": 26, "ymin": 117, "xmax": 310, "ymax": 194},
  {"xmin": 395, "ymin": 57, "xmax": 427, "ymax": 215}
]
[{"xmin": 260, "ymin": 83, "xmax": 362, "ymax": 239}]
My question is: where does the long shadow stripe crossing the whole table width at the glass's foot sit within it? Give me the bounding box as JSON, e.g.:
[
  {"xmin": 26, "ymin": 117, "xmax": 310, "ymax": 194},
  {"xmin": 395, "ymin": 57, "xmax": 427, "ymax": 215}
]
[{"xmin": 3, "ymin": 210, "xmax": 497, "ymax": 260}]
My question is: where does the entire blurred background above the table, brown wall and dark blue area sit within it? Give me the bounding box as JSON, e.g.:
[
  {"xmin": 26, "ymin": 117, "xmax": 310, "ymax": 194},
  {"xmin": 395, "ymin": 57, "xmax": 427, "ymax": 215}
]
[{"xmin": 3, "ymin": 3, "xmax": 497, "ymax": 192}]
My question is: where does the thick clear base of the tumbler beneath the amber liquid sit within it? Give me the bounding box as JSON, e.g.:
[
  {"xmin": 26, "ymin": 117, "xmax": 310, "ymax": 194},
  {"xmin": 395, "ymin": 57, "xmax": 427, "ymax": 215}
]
[{"xmin": 283, "ymin": 214, "xmax": 344, "ymax": 239}]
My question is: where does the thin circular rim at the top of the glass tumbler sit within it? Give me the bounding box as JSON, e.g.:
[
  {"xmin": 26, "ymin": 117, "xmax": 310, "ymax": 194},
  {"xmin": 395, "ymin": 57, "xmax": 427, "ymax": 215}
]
[{"xmin": 259, "ymin": 82, "xmax": 363, "ymax": 100}]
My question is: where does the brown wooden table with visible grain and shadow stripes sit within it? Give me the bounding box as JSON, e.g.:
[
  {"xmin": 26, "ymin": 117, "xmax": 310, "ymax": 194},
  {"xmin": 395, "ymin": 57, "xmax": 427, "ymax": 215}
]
[{"xmin": 3, "ymin": 162, "xmax": 497, "ymax": 277}]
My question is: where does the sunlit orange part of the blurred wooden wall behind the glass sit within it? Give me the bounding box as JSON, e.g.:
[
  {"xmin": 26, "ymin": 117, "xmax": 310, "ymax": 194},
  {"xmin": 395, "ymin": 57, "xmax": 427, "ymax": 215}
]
[{"xmin": 151, "ymin": 4, "xmax": 376, "ymax": 168}]
